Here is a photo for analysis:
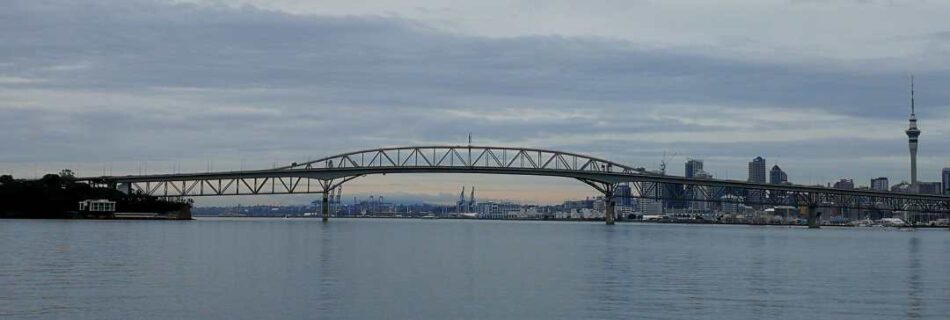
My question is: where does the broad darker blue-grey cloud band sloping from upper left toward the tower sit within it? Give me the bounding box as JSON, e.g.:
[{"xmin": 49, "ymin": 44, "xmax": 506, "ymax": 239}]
[{"xmin": 7, "ymin": 1, "xmax": 950, "ymax": 116}]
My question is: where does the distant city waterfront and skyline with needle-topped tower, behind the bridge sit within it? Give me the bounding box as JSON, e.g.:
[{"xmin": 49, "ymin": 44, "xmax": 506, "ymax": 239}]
[{"xmin": 199, "ymin": 80, "xmax": 950, "ymax": 224}]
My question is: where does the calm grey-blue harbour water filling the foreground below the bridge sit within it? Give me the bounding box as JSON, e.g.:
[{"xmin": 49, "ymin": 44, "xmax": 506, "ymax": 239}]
[{"xmin": 0, "ymin": 218, "xmax": 950, "ymax": 319}]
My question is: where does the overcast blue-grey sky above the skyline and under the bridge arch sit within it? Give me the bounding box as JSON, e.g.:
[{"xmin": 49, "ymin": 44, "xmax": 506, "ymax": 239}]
[{"xmin": 0, "ymin": 0, "xmax": 950, "ymax": 204}]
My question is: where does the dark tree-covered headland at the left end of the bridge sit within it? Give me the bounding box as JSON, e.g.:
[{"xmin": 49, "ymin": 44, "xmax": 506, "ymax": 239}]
[{"xmin": 0, "ymin": 170, "xmax": 190, "ymax": 219}]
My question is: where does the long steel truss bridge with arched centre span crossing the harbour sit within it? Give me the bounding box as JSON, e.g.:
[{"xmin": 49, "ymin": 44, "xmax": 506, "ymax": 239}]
[{"xmin": 79, "ymin": 146, "xmax": 950, "ymax": 227}]
